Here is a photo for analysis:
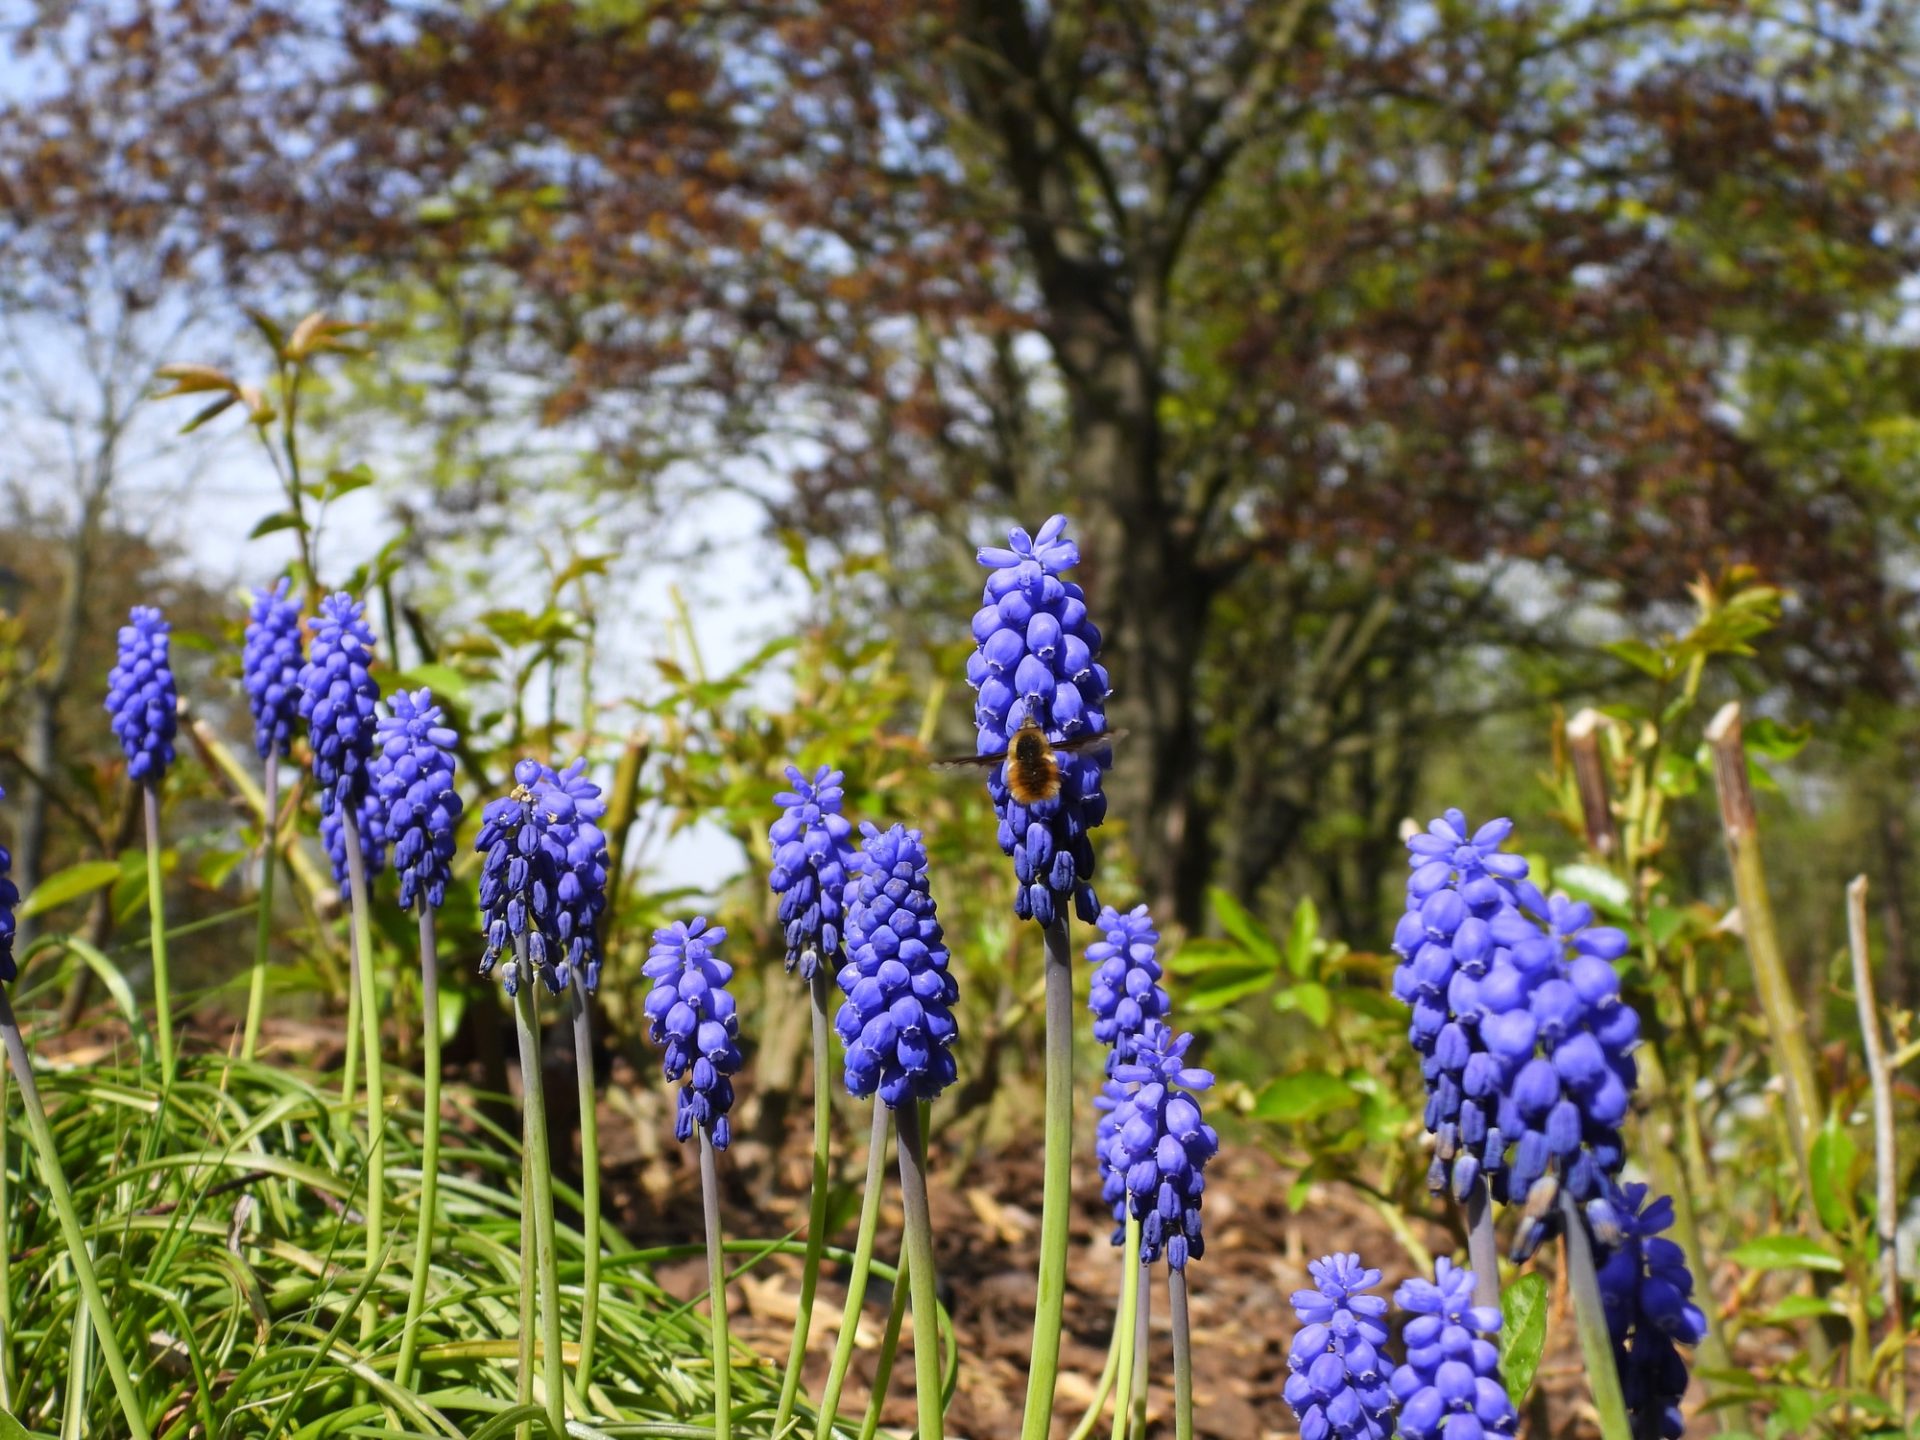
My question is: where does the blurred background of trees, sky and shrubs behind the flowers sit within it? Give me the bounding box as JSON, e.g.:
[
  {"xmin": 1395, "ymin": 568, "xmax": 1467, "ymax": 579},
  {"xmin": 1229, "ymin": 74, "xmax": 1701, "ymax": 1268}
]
[{"xmin": 0, "ymin": 0, "xmax": 1920, "ymax": 1432}]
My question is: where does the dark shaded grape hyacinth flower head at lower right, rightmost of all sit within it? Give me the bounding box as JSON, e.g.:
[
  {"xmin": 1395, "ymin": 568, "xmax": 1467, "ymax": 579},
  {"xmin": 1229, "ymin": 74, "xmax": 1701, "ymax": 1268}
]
[{"xmin": 1599, "ymin": 1185, "xmax": 1707, "ymax": 1440}]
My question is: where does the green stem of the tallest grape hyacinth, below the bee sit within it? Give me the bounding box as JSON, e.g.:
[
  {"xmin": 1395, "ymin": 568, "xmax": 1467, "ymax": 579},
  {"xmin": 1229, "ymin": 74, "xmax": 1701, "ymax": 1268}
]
[{"xmin": 1020, "ymin": 916, "xmax": 1073, "ymax": 1440}]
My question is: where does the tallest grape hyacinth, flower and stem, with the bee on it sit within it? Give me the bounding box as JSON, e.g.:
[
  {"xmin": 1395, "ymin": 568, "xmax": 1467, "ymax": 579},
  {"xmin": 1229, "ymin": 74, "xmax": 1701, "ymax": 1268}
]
[{"xmin": 966, "ymin": 515, "xmax": 1112, "ymax": 1440}]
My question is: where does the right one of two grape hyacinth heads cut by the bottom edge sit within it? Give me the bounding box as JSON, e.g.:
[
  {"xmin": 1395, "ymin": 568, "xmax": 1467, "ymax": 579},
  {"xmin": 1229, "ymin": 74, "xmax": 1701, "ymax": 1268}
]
[{"xmin": 1390, "ymin": 1258, "xmax": 1519, "ymax": 1440}]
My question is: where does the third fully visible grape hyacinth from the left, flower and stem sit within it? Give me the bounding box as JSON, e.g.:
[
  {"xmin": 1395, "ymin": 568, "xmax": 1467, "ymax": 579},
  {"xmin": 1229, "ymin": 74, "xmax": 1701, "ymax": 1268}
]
[{"xmin": 300, "ymin": 593, "xmax": 386, "ymax": 1297}]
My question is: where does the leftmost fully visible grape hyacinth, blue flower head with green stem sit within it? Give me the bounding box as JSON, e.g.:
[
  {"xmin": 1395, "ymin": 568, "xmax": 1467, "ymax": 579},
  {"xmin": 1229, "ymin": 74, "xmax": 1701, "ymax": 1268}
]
[{"xmin": 106, "ymin": 605, "xmax": 180, "ymax": 1079}]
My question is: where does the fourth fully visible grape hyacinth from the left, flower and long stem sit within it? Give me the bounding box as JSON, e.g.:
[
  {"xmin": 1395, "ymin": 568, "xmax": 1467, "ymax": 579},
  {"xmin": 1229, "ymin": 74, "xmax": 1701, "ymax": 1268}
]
[{"xmin": 372, "ymin": 689, "xmax": 461, "ymax": 1386}]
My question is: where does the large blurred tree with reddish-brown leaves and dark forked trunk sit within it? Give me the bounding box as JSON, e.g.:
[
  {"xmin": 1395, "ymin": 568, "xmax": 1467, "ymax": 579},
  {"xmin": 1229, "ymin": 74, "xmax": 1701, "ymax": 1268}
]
[{"xmin": 0, "ymin": 0, "xmax": 1920, "ymax": 920}]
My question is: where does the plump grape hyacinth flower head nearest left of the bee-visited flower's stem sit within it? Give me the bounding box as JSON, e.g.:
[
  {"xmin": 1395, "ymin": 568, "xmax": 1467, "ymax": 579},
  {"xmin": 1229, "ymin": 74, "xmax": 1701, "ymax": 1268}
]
[{"xmin": 833, "ymin": 824, "xmax": 960, "ymax": 1110}]
